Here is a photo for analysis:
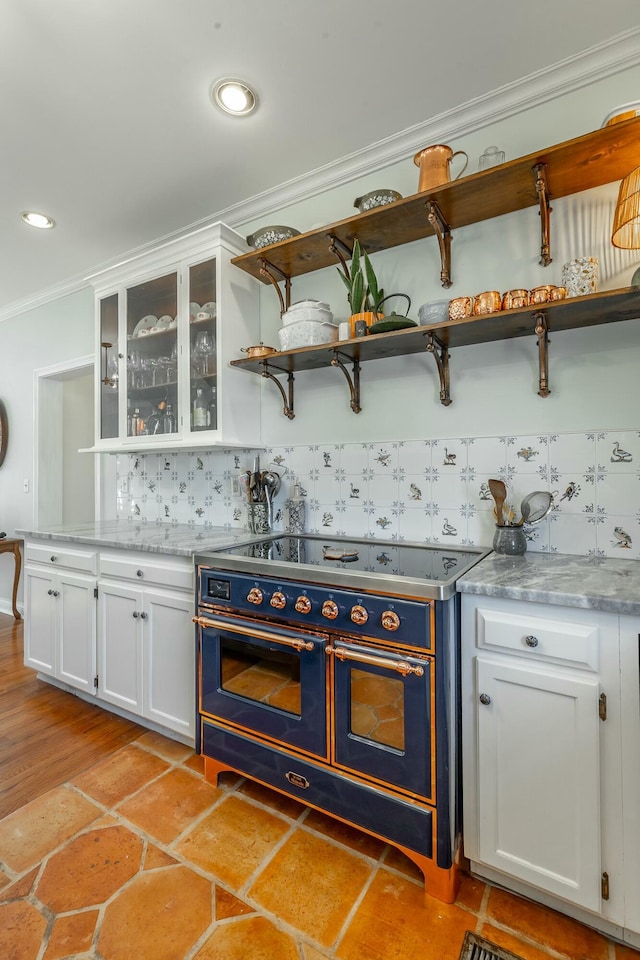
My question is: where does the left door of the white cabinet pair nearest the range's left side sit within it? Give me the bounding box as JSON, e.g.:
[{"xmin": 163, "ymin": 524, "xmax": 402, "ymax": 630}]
[{"xmin": 98, "ymin": 581, "xmax": 144, "ymax": 714}]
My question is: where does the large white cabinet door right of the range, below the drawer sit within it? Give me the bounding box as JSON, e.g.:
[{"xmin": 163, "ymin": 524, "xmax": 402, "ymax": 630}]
[{"xmin": 476, "ymin": 656, "xmax": 601, "ymax": 910}]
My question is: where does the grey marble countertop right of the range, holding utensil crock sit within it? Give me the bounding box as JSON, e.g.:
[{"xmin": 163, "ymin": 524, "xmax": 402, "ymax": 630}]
[{"xmin": 456, "ymin": 553, "xmax": 640, "ymax": 615}]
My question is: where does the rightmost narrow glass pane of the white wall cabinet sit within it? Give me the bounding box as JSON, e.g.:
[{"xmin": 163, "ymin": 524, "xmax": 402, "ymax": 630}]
[{"xmin": 189, "ymin": 258, "xmax": 218, "ymax": 431}]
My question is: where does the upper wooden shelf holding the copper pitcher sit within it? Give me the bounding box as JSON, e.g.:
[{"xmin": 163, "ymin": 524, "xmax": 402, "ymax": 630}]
[{"xmin": 231, "ymin": 117, "xmax": 640, "ymax": 283}]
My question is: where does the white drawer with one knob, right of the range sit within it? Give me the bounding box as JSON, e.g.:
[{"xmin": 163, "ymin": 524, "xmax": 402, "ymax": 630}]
[{"xmin": 476, "ymin": 606, "xmax": 599, "ymax": 670}]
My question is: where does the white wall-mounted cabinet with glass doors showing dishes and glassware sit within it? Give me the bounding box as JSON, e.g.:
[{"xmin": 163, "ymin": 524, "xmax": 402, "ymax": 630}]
[{"xmin": 91, "ymin": 224, "xmax": 260, "ymax": 451}]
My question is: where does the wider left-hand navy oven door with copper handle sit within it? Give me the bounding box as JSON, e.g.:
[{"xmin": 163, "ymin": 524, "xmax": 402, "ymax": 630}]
[{"xmin": 196, "ymin": 616, "xmax": 328, "ymax": 759}]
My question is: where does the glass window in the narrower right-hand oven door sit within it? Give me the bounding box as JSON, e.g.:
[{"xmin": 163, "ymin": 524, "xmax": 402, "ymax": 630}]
[{"xmin": 351, "ymin": 668, "xmax": 404, "ymax": 750}]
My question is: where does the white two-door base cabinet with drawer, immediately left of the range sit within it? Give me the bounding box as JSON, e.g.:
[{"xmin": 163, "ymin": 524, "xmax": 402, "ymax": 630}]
[{"xmin": 98, "ymin": 554, "xmax": 195, "ymax": 739}]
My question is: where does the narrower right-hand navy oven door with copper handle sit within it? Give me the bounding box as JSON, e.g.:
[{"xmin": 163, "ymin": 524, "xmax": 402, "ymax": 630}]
[{"xmin": 328, "ymin": 641, "xmax": 435, "ymax": 801}]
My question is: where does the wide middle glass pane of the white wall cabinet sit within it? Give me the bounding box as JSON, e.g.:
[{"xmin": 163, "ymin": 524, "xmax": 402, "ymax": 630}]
[{"xmin": 127, "ymin": 273, "xmax": 178, "ymax": 437}]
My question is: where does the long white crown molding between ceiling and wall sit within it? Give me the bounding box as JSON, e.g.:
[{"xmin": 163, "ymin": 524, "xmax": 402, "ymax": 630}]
[{"xmin": 0, "ymin": 27, "xmax": 640, "ymax": 321}]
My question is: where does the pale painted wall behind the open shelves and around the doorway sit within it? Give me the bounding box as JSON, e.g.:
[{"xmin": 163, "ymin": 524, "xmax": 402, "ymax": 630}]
[{"xmin": 0, "ymin": 58, "xmax": 640, "ymax": 598}]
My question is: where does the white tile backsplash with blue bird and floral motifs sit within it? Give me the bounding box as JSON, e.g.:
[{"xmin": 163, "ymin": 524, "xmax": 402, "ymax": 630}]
[{"xmin": 117, "ymin": 430, "xmax": 640, "ymax": 559}]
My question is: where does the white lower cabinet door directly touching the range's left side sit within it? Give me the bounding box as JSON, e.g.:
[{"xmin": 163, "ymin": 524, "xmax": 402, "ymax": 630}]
[{"xmin": 142, "ymin": 590, "xmax": 195, "ymax": 737}]
